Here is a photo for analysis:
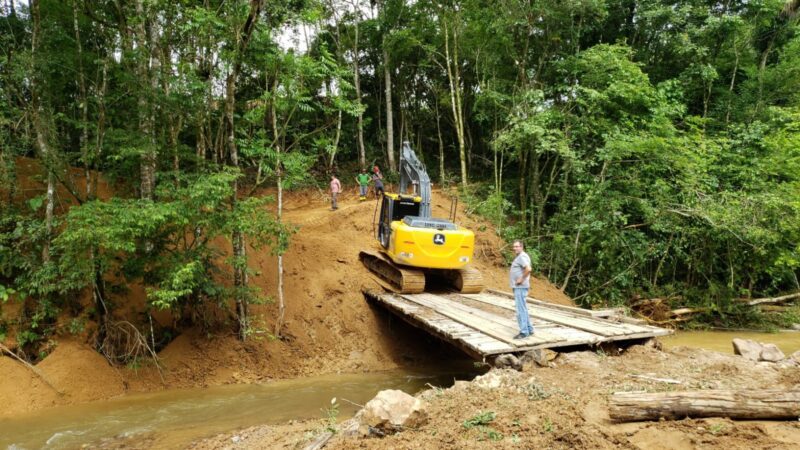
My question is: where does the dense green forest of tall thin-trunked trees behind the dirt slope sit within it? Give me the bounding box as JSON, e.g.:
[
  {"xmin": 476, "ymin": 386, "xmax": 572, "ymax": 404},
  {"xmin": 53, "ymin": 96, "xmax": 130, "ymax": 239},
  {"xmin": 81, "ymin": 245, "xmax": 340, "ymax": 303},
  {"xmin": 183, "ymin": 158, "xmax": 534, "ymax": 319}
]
[{"xmin": 0, "ymin": 0, "xmax": 800, "ymax": 358}]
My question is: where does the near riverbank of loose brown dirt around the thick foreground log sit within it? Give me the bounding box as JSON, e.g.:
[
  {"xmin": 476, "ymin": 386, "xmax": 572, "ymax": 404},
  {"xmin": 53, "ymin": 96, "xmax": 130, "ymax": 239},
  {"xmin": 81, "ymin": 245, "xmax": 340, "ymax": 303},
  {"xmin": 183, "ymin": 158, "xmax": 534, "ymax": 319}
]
[{"xmin": 192, "ymin": 343, "xmax": 800, "ymax": 450}]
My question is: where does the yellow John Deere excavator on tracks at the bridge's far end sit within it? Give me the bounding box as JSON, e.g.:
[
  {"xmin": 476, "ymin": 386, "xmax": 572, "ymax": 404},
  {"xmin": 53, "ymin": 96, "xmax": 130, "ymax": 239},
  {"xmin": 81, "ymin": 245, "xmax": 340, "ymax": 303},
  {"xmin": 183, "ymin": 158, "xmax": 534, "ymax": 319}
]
[{"xmin": 359, "ymin": 142, "xmax": 483, "ymax": 294}]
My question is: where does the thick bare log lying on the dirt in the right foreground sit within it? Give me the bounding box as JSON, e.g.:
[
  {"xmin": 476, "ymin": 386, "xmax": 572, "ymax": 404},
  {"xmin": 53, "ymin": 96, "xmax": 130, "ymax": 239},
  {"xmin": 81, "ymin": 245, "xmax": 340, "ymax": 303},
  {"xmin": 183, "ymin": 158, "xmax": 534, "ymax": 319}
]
[{"xmin": 609, "ymin": 389, "xmax": 800, "ymax": 422}]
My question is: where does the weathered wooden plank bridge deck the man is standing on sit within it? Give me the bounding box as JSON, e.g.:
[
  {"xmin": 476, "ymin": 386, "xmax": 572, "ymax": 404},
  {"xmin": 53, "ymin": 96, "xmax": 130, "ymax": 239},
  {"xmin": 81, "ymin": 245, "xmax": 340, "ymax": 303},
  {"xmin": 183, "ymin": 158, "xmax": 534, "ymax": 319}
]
[{"xmin": 364, "ymin": 290, "xmax": 672, "ymax": 359}]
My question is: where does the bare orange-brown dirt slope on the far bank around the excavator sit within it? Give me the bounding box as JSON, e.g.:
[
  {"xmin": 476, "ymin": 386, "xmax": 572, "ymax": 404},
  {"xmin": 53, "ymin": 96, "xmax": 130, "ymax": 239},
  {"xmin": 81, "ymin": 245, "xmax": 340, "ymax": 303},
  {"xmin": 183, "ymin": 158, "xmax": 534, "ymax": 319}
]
[{"xmin": 0, "ymin": 184, "xmax": 570, "ymax": 416}]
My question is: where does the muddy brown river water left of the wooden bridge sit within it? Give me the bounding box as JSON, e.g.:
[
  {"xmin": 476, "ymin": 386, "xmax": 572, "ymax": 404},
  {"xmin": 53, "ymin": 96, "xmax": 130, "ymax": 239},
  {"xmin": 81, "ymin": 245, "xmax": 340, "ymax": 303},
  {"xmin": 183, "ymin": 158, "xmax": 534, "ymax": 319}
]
[{"xmin": 0, "ymin": 362, "xmax": 480, "ymax": 450}]
